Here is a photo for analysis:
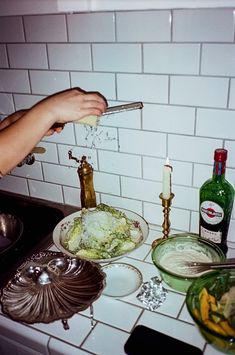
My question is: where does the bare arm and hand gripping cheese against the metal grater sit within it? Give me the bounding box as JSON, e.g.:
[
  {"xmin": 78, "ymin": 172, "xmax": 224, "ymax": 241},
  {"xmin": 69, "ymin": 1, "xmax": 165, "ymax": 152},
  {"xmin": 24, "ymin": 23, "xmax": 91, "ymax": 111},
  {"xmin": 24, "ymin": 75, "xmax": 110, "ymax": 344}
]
[{"xmin": 0, "ymin": 89, "xmax": 106, "ymax": 175}]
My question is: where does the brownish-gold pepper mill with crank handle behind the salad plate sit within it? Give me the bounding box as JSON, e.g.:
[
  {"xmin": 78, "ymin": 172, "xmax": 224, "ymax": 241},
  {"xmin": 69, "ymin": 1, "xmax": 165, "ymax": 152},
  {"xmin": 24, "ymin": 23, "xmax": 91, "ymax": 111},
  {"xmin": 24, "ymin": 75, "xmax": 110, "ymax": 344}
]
[{"xmin": 68, "ymin": 151, "xmax": 96, "ymax": 208}]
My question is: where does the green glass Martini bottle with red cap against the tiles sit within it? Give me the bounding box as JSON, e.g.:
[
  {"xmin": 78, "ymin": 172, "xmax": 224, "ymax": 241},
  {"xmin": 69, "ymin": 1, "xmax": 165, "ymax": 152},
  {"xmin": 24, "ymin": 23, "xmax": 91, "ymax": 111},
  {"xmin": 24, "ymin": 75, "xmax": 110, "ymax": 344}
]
[{"xmin": 199, "ymin": 149, "xmax": 235, "ymax": 255}]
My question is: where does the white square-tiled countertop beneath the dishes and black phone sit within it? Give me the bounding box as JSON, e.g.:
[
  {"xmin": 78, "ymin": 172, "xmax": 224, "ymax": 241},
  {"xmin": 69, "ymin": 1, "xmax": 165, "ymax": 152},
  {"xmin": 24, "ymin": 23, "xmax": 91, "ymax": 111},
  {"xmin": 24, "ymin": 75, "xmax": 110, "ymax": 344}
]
[{"xmin": 0, "ymin": 226, "xmax": 235, "ymax": 355}]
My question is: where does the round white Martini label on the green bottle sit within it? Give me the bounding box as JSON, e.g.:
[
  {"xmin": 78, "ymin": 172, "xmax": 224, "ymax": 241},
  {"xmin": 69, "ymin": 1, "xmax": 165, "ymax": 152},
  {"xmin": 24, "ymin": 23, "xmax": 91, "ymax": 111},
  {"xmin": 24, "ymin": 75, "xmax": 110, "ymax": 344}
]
[{"xmin": 200, "ymin": 201, "xmax": 224, "ymax": 225}]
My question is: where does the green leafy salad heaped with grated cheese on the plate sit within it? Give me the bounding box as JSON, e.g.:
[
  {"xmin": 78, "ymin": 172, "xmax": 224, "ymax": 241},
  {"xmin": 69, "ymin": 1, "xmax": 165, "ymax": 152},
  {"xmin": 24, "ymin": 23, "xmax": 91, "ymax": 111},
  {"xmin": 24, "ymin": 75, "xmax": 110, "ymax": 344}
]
[{"xmin": 63, "ymin": 203, "xmax": 143, "ymax": 259}]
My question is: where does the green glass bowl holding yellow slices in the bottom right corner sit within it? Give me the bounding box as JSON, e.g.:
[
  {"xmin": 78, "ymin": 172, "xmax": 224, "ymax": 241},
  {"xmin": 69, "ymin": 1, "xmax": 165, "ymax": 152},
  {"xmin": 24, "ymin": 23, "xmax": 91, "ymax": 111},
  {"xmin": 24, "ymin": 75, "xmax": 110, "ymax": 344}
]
[{"xmin": 186, "ymin": 269, "xmax": 235, "ymax": 354}]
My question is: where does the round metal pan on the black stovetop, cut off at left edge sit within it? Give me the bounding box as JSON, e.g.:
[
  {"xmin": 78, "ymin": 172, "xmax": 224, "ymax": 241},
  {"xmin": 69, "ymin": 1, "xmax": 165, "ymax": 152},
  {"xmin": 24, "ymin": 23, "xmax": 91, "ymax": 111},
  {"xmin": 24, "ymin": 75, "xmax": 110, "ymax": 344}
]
[{"xmin": 0, "ymin": 213, "xmax": 23, "ymax": 254}]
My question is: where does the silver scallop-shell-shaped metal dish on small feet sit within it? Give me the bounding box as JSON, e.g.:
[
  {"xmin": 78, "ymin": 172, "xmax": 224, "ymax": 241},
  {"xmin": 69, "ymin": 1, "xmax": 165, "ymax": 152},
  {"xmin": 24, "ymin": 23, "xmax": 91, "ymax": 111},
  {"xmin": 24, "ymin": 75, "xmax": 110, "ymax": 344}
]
[{"xmin": 0, "ymin": 250, "xmax": 106, "ymax": 329}]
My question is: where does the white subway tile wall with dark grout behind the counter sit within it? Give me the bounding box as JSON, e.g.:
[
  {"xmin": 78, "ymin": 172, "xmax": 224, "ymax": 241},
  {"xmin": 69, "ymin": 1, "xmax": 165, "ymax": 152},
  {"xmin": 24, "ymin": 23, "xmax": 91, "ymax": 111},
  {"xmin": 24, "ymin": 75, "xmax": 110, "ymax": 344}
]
[{"xmin": 0, "ymin": 8, "xmax": 235, "ymax": 245}]
